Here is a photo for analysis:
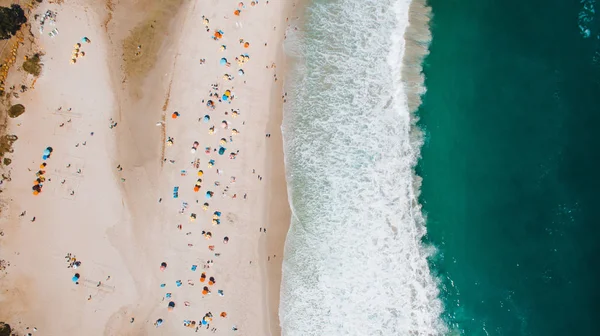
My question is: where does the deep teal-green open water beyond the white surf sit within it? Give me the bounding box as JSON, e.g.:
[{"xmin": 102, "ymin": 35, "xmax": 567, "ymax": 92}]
[{"xmin": 417, "ymin": 0, "xmax": 600, "ymax": 336}]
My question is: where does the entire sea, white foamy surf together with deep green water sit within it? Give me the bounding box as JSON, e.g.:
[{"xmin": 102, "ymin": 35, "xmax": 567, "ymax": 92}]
[{"xmin": 279, "ymin": 0, "xmax": 600, "ymax": 336}]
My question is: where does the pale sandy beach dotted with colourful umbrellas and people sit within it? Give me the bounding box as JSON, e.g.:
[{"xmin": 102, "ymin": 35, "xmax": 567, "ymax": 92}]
[{"xmin": 0, "ymin": 0, "xmax": 293, "ymax": 335}]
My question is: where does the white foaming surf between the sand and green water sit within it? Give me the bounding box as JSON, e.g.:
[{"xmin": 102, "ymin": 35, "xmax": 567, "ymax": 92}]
[{"xmin": 280, "ymin": 0, "xmax": 446, "ymax": 336}]
